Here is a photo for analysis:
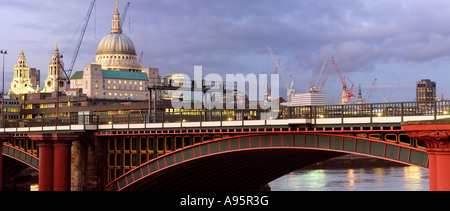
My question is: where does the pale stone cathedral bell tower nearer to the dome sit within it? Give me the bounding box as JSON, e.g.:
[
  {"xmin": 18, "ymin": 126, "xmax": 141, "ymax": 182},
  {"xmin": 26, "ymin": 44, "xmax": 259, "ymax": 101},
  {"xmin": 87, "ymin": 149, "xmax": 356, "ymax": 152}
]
[{"xmin": 42, "ymin": 44, "xmax": 67, "ymax": 92}]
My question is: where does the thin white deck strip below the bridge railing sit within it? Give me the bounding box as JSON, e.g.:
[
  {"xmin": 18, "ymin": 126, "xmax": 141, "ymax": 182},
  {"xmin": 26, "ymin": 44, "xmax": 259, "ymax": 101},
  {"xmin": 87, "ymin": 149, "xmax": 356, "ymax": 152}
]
[{"xmin": 0, "ymin": 115, "xmax": 448, "ymax": 133}]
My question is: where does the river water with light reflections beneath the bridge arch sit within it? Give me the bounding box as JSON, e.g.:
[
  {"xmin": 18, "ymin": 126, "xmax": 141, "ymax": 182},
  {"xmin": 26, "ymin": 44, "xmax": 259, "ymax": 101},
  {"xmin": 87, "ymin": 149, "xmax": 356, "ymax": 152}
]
[{"xmin": 269, "ymin": 166, "xmax": 428, "ymax": 191}]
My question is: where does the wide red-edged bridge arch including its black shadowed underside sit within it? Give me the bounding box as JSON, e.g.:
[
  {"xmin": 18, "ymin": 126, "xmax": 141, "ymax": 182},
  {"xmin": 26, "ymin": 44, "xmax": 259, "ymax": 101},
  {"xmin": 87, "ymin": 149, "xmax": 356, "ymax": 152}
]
[{"xmin": 106, "ymin": 133, "xmax": 428, "ymax": 191}]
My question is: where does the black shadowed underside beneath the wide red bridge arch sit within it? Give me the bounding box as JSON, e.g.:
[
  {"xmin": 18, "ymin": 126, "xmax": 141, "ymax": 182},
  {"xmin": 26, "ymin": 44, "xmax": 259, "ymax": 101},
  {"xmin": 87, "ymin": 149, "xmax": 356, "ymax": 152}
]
[{"xmin": 121, "ymin": 148, "xmax": 344, "ymax": 191}]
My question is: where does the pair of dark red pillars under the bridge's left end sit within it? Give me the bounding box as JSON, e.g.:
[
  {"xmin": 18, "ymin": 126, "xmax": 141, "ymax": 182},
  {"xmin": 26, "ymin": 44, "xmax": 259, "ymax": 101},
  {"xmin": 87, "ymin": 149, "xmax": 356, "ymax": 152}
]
[{"xmin": 30, "ymin": 134, "xmax": 78, "ymax": 191}]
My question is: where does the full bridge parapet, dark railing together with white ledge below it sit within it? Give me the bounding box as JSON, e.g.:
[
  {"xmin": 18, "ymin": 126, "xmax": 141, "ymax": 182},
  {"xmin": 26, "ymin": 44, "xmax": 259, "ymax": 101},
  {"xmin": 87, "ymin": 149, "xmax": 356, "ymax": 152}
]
[{"xmin": 0, "ymin": 101, "xmax": 450, "ymax": 133}]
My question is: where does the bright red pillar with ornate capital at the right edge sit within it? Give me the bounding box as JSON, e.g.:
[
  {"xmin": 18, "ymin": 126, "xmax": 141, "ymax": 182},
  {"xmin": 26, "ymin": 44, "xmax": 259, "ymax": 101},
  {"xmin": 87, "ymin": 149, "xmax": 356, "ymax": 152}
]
[{"xmin": 403, "ymin": 123, "xmax": 450, "ymax": 191}]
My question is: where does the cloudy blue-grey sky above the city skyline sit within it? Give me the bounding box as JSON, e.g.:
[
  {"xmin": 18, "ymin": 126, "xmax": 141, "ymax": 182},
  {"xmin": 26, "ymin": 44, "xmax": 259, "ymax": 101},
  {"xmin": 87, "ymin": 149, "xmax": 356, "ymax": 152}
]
[{"xmin": 0, "ymin": 0, "xmax": 450, "ymax": 103}]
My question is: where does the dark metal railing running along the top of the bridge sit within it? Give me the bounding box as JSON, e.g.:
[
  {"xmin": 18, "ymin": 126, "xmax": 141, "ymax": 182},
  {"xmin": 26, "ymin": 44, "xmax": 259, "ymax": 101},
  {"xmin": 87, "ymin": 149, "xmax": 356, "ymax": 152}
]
[{"xmin": 0, "ymin": 101, "xmax": 450, "ymax": 129}]
